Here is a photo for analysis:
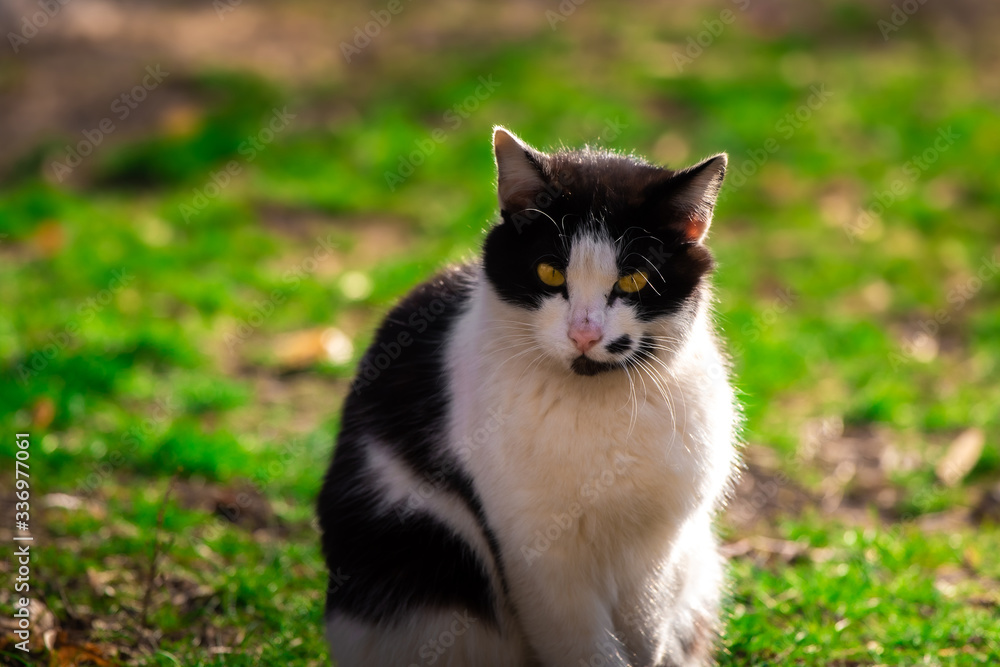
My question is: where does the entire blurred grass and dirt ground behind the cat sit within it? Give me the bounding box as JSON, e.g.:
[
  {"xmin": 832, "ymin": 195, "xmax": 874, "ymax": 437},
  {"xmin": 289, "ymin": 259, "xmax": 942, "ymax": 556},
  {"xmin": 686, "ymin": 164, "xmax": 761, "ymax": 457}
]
[{"xmin": 0, "ymin": 0, "xmax": 1000, "ymax": 665}]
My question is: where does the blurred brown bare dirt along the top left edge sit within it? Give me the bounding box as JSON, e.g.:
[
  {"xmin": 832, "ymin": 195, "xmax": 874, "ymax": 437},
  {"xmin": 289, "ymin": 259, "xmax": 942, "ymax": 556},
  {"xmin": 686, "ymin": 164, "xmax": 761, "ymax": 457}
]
[{"xmin": 0, "ymin": 0, "xmax": 548, "ymax": 183}]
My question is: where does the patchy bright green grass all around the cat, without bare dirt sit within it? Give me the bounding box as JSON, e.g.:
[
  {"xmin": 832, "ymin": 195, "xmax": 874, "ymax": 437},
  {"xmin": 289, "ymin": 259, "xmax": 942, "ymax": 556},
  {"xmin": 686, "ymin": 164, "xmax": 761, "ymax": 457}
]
[{"xmin": 0, "ymin": 3, "xmax": 1000, "ymax": 665}]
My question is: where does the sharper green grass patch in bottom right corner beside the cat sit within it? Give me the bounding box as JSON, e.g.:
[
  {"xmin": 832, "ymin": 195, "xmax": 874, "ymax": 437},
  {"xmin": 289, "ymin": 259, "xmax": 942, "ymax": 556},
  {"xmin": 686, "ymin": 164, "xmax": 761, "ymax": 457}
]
[{"xmin": 720, "ymin": 520, "xmax": 1000, "ymax": 665}]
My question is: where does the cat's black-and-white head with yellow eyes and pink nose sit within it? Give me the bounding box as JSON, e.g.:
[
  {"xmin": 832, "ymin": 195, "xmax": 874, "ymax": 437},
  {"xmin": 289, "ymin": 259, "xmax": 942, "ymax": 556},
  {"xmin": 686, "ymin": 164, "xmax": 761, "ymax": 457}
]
[{"xmin": 483, "ymin": 127, "xmax": 726, "ymax": 375}]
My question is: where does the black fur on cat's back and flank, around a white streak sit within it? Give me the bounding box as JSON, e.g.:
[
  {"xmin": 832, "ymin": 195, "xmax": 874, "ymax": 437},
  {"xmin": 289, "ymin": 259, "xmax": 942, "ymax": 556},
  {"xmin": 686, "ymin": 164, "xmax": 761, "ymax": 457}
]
[{"xmin": 318, "ymin": 266, "xmax": 506, "ymax": 624}]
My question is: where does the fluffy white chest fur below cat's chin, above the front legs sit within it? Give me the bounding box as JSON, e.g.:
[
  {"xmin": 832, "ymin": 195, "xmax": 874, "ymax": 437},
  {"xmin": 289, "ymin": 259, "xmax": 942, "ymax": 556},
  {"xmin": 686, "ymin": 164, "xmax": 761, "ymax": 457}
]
[{"xmin": 449, "ymin": 280, "xmax": 734, "ymax": 576}]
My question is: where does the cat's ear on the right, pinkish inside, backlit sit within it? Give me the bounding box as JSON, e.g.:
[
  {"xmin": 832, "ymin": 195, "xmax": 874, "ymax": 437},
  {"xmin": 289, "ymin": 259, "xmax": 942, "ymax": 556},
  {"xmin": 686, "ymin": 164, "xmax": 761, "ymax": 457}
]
[{"xmin": 656, "ymin": 153, "xmax": 729, "ymax": 243}]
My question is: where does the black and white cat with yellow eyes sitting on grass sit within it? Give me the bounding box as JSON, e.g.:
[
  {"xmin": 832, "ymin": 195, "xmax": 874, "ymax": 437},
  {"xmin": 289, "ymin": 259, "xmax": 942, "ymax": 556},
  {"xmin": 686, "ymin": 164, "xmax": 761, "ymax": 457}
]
[{"xmin": 318, "ymin": 127, "xmax": 738, "ymax": 667}]
